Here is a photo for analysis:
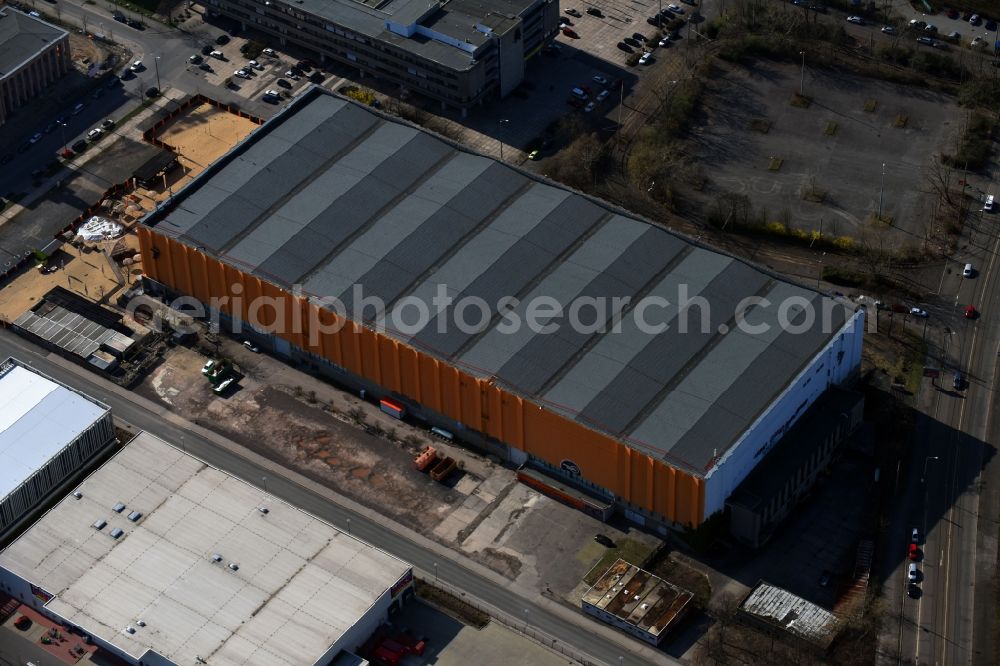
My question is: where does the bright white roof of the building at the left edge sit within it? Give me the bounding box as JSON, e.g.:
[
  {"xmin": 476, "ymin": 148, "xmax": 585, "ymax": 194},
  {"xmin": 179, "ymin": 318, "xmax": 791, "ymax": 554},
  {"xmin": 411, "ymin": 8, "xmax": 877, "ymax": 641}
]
[{"xmin": 0, "ymin": 361, "xmax": 107, "ymax": 498}]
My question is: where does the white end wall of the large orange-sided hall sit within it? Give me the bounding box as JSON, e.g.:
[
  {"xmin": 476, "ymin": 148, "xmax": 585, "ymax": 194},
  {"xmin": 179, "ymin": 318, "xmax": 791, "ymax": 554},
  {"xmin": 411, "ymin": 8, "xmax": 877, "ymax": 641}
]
[{"xmin": 704, "ymin": 310, "xmax": 865, "ymax": 518}]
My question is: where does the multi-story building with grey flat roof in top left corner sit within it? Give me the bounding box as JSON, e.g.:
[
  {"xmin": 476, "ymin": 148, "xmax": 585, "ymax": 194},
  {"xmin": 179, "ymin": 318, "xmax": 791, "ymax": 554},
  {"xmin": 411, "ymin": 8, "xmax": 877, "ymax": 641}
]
[{"xmin": 0, "ymin": 7, "xmax": 72, "ymax": 125}]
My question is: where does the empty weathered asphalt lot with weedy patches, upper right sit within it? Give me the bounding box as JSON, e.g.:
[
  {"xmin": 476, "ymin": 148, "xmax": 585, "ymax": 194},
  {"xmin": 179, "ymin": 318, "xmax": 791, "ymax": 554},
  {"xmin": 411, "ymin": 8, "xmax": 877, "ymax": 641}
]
[{"xmin": 693, "ymin": 60, "xmax": 966, "ymax": 245}]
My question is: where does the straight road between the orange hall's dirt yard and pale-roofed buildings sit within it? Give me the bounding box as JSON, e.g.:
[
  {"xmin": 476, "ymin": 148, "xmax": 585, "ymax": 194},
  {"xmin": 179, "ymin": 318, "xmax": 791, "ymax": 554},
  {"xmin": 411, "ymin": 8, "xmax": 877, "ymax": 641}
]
[{"xmin": 0, "ymin": 329, "xmax": 676, "ymax": 665}]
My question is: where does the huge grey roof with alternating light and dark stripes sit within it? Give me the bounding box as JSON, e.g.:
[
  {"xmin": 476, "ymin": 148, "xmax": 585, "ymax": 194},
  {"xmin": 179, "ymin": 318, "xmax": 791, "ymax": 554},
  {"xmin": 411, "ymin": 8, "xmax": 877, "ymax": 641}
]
[{"xmin": 145, "ymin": 88, "xmax": 853, "ymax": 474}]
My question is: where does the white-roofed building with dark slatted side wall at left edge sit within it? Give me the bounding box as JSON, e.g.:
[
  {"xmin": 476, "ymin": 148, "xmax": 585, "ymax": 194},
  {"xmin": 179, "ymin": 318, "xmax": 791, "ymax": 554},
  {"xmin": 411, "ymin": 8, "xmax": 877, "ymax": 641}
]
[{"xmin": 0, "ymin": 358, "xmax": 115, "ymax": 535}]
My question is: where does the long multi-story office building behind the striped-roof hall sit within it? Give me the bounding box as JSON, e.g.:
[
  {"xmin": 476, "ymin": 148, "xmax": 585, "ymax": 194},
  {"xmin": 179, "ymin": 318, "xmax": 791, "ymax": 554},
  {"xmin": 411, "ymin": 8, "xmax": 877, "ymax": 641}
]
[{"xmin": 206, "ymin": 0, "xmax": 559, "ymax": 113}]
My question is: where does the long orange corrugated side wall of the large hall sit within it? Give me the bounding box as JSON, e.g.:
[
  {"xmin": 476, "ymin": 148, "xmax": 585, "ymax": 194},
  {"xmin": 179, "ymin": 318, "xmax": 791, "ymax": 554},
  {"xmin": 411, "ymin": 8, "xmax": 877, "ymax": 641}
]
[{"xmin": 138, "ymin": 237, "xmax": 705, "ymax": 525}]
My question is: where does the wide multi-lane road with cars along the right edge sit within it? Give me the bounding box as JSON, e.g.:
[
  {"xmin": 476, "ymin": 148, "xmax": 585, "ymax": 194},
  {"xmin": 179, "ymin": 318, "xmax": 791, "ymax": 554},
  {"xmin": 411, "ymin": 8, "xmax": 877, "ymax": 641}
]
[{"xmin": 886, "ymin": 200, "xmax": 1000, "ymax": 664}]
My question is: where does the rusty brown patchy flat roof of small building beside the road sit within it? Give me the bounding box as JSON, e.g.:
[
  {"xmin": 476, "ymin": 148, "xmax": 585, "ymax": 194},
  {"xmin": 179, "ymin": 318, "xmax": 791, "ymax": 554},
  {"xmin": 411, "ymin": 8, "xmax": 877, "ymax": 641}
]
[{"xmin": 583, "ymin": 559, "xmax": 694, "ymax": 638}]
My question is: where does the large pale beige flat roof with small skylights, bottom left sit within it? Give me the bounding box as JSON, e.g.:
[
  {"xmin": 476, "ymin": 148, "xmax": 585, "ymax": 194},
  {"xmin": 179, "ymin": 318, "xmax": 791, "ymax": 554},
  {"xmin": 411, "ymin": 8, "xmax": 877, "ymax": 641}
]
[{"xmin": 0, "ymin": 433, "xmax": 410, "ymax": 666}]
